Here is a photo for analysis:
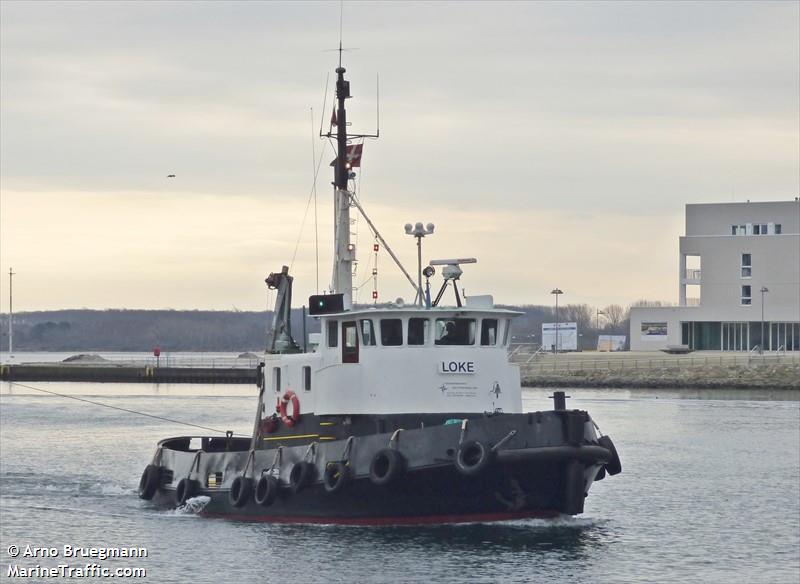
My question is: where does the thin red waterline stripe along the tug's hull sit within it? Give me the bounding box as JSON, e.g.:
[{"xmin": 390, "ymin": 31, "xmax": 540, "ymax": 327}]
[{"xmin": 200, "ymin": 511, "xmax": 559, "ymax": 525}]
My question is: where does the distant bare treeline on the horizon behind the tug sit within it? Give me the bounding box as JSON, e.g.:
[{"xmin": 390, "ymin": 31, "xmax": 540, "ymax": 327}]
[{"xmin": 0, "ymin": 301, "xmax": 644, "ymax": 352}]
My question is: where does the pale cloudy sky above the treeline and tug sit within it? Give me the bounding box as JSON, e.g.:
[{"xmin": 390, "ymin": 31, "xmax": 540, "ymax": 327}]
[{"xmin": 0, "ymin": 1, "xmax": 800, "ymax": 312}]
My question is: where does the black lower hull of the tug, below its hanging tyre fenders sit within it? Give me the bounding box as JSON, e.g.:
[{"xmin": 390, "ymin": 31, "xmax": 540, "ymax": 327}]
[{"xmin": 156, "ymin": 463, "xmax": 584, "ymax": 525}]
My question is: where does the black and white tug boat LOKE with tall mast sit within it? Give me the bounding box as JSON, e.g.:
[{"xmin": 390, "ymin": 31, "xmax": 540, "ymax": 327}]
[{"xmin": 139, "ymin": 58, "xmax": 622, "ymax": 525}]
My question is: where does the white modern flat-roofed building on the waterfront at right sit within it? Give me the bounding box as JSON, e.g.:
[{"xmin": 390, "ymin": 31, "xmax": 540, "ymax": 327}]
[{"xmin": 631, "ymin": 199, "xmax": 800, "ymax": 351}]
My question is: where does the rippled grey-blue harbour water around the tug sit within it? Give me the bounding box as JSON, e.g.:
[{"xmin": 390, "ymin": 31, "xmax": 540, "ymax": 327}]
[{"xmin": 0, "ymin": 383, "xmax": 800, "ymax": 584}]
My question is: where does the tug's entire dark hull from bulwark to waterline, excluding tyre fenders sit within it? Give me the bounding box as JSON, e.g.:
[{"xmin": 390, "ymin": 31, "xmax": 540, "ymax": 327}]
[{"xmin": 146, "ymin": 411, "xmax": 619, "ymax": 525}]
